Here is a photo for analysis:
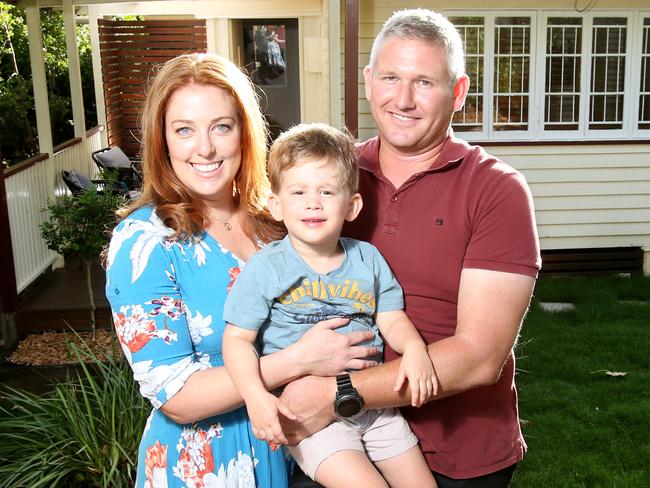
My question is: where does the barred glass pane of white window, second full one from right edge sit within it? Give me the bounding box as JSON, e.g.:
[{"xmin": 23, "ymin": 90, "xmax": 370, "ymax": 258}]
[{"xmin": 544, "ymin": 17, "xmax": 582, "ymax": 130}]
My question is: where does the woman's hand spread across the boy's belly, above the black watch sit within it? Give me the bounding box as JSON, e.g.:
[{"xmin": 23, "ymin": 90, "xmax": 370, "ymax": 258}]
[{"xmin": 287, "ymin": 318, "xmax": 377, "ymax": 376}]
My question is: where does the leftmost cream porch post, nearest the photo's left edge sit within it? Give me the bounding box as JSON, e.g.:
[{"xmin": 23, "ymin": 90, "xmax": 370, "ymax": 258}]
[{"xmin": 23, "ymin": 0, "xmax": 54, "ymax": 156}]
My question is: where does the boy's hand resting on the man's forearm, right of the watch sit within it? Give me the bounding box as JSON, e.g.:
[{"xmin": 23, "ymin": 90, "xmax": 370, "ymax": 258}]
[{"xmin": 395, "ymin": 341, "xmax": 438, "ymax": 407}]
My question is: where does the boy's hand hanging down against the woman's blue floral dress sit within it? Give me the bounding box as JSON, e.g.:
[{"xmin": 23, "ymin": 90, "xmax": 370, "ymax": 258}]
[{"xmin": 246, "ymin": 391, "xmax": 296, "ymax": 445}]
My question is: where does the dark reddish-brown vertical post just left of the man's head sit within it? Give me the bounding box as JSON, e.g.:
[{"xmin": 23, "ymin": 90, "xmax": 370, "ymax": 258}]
[{"xmin": 345, "ymin": 0, "xmax": 359, "ymax": 137}]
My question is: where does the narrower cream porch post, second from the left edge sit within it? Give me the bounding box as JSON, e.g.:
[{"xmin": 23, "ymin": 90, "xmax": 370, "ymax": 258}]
[{"xmin": 63, "ymin": 0, "xmax": 86, "ymax": 139}]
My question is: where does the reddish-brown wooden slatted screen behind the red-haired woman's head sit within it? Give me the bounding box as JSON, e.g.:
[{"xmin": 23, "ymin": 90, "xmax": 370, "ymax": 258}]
[{"xmin": 98, "ymin": 19, "xmax": 207, "ymax": 157}]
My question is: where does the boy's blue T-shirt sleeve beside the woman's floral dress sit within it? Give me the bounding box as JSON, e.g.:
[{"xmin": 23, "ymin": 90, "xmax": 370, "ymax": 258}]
[{"xmin": 223, "ymin": 255, "xmax": 274, "ymax": 330}]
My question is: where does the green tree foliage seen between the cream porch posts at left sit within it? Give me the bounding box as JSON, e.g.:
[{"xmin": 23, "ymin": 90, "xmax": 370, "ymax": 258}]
[{"xmin": 0, "ymin": 2, "xmax": 97, "ymax": 166}]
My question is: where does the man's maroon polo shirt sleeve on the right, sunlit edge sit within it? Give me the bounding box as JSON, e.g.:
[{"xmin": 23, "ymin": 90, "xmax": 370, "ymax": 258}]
[{"xmin": 463, "ymin": 169, "xmax": 541, "ymax": 277}]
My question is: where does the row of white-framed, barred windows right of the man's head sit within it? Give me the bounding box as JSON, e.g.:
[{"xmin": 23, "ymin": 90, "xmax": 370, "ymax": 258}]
[{"xmin": 447, "ymin": 11, "xmax": 650, "ymax": 140}]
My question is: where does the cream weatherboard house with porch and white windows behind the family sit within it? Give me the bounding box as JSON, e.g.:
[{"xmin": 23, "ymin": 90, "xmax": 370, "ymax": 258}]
[{"xmin": 0, "ymin": 0, "xmax": 650, "ymax": 350}]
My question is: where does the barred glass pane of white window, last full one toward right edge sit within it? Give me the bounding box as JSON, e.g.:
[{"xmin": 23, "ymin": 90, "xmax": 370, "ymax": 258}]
[{"xmin": 589, "ymin": 17, "xmax": 627, "ymax": 130}]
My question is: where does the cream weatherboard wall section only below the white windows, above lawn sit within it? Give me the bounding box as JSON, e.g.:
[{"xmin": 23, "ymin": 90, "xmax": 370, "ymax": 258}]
[{"xmin": 487, "ymin": 144, "xmax": 650, "ymax": 260}]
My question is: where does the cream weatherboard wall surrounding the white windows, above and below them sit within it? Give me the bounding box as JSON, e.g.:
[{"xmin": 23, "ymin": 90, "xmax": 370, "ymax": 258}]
[{"xmin": 341, "ymin": 0, "xmax": 650, "ymax": 274}]
